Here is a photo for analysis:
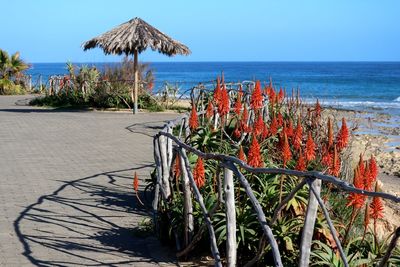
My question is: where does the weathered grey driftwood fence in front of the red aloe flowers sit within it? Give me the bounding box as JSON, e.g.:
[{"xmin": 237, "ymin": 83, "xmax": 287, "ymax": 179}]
[{"xmin": 152, "ymin": 83, "xmax": 400, "ymax": 267}]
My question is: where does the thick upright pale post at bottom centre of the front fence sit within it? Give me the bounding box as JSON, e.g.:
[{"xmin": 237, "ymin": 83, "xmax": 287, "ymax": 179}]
[{"xmin": 224, "ymin": 168, "xmax": 236, "ymax": 267}]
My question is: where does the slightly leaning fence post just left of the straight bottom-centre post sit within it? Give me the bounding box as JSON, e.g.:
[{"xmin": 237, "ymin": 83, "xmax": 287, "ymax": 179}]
[{"xmin": 180, "ymin": 153, "xmax": 194, "ymax": 247}]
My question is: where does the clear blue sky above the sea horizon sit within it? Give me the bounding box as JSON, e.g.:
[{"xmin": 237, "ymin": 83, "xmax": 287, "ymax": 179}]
[{"xmin": 0, "ymin": 0, "xmax": 400, "ymax": 63}]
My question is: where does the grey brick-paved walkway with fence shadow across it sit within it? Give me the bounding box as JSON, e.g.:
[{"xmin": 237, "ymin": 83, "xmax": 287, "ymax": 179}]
[{"xmin": 0, "ymin": 96, "xmax": 177, "ymax": 267}]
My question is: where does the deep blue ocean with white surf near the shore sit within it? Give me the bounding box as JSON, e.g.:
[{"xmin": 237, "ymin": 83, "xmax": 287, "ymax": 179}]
[{"xmin": 28, "ymin": 62, "xmax": 400, "ymax": 115}]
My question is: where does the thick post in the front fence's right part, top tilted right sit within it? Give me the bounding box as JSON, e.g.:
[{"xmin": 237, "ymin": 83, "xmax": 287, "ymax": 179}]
[{"xmin": 299, "ymin": 179, "xmax": 321, "ymax": 267}]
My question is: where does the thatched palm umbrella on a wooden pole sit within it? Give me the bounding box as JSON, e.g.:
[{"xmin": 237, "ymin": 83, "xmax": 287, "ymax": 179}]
[{"xmin": 82, "ymin": 18, "xmax": 191, "ymax": 113}]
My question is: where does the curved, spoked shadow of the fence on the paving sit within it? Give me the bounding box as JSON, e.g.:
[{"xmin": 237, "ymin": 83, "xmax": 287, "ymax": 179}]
[{"xmin": 14, "ymin": 165, "xmax": 174, "ymax": 266}]
